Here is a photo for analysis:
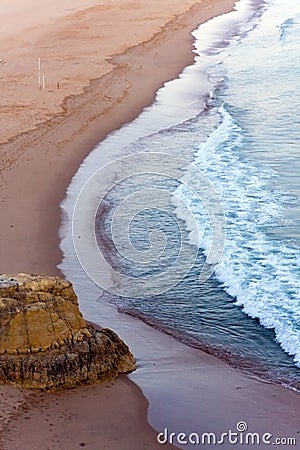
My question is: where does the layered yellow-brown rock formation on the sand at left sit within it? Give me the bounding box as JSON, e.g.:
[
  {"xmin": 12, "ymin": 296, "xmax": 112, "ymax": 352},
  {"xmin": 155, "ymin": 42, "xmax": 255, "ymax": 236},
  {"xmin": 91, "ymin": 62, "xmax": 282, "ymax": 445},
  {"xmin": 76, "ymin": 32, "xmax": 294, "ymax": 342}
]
[{"xmin": 0, "ymin": 274, "xmax": 135, "ymax": 389}]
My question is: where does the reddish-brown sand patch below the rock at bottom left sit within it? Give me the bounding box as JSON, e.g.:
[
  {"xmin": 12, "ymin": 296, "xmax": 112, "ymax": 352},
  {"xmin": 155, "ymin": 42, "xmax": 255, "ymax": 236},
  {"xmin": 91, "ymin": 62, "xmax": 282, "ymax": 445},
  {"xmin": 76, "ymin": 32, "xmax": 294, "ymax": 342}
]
[{"xmin": 0, "ymin": 376, "xmax": 174, "ymax": 450}]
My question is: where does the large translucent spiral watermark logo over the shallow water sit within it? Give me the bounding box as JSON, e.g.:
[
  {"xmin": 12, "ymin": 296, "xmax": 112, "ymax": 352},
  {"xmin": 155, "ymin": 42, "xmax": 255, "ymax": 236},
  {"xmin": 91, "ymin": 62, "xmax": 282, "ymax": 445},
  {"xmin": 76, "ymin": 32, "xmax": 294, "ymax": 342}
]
[{"xmin": 72, "ymin": 152, "xmax": 225, "ymax": 298}]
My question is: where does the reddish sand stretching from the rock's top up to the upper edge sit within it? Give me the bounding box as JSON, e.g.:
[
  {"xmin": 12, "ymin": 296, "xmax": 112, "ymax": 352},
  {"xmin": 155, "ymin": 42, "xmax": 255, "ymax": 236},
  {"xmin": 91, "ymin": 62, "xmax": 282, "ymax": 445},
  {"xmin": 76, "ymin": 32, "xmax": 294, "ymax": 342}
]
[{"xmin": 0, "ymin": 0, "xmax": 233, "ymax": 275}]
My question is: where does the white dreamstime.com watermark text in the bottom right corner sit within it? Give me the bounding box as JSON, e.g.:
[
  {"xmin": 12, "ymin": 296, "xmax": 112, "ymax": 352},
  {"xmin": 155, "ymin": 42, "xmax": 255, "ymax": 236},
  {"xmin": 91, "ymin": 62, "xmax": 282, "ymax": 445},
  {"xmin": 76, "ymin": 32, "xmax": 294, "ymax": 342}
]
[{"xmin": 157, "ymin": 421, "xmax": 297, "ymax": 448}]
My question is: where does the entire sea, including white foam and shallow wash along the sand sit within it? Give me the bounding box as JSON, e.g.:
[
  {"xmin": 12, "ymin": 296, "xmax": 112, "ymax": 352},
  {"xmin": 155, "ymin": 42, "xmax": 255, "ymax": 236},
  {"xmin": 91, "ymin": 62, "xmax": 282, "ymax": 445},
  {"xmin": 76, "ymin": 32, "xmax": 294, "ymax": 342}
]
[{"xmin": 61, "ymin": 0, "xmax": 300, "ymax": 389}]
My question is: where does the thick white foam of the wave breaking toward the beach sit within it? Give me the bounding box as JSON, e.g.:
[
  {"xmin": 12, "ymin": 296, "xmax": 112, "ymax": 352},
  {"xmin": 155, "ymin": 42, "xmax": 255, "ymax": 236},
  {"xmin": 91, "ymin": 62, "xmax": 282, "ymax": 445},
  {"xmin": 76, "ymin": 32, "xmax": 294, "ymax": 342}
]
[{"xmin": 177, "ymin": 106, "xmax": 300, "ymax": 366}]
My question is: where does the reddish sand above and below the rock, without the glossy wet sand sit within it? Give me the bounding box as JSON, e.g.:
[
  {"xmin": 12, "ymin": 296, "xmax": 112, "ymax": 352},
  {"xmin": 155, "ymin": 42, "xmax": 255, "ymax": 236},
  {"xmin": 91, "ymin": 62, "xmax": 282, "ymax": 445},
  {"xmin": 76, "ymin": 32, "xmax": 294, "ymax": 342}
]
[{"xmin": 0, "ymin": 0, "xmax": 239, "ymax": 450}]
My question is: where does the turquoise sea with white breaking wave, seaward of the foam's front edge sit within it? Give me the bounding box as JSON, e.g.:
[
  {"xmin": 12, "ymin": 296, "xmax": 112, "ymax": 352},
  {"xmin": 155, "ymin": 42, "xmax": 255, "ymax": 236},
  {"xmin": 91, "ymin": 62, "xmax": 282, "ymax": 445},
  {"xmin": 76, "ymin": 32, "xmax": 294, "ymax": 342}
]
[{"xmin": 189, "ymin": 0, "xmax": 300, "ymax": 364}]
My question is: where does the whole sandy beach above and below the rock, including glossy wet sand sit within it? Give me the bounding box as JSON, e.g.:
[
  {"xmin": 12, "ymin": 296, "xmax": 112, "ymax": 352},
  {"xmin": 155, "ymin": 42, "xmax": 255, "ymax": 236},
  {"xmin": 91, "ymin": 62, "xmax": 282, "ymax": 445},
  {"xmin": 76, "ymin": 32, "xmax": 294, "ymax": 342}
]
[{"xmin": 0, "ymin": 0, "xmax": 300, "ymax": 450}]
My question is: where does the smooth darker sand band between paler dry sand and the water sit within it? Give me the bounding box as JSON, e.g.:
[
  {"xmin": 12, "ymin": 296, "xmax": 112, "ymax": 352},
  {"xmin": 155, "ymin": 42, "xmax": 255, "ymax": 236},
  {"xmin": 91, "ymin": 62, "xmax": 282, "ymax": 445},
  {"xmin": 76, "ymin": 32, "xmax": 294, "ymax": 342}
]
[{"xmin": 0, "ymin": 0, "xmax": 234, "ymax": 275}]
